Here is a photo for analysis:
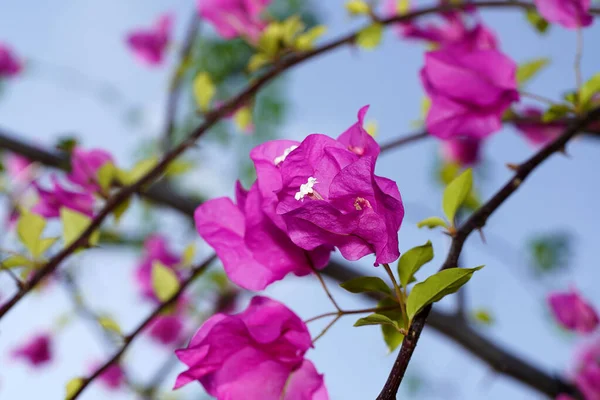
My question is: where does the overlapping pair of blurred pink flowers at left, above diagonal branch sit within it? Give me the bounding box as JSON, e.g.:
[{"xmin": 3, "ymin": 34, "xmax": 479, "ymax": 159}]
[{"xmin": 32, "ymin": 148, "xmax": 113, "ymax": 218}]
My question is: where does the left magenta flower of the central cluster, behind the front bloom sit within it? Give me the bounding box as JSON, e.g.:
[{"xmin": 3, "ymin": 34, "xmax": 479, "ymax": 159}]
[{"xmin": 194, "ymin": 183, "xmax": 329, "ymax": 290}]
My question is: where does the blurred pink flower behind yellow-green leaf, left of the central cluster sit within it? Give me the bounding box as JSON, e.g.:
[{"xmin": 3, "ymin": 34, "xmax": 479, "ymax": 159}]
[{"xmin": 135, "ymin": 235, "xmax": 181, "ymax": 301}]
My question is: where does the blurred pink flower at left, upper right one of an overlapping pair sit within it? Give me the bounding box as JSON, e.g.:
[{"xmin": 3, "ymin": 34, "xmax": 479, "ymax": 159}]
[{"xmin": 68, "ymin": 148, "xmax": 113, "ymax": 192}]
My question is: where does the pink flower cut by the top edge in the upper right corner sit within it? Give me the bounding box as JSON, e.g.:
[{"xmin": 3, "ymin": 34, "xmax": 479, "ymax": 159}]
[{"xmin": 535, "ymin": 0, "xmax": 594, "ymax": 29}]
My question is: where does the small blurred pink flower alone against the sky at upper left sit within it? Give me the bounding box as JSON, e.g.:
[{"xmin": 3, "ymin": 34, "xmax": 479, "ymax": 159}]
[{"xmin": 127, "ymin": 14, "xmax": 173, "ymax": 66}]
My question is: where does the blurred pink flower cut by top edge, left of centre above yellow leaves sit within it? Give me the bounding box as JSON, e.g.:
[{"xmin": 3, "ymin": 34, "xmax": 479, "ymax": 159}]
[{"xmin": 198, "ymin": 0, "xmax": 271, "ymax": 42}]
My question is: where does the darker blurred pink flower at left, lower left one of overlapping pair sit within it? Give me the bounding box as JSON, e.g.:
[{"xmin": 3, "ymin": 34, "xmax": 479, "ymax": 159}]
[{"xmin": 31, "ymin": 176, "xmax": 94, "ymax": 218}]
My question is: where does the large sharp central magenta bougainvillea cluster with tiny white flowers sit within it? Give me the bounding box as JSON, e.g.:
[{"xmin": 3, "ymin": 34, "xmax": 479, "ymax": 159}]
[{"xmin": 195, "ymin": 107, "xmax": 404, "ymax": 290}]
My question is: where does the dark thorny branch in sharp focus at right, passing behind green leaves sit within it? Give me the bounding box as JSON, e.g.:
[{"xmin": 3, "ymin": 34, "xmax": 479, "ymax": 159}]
[{"xmin": 377, "ymin": 108, "xmax": 600, "ymax": 400}]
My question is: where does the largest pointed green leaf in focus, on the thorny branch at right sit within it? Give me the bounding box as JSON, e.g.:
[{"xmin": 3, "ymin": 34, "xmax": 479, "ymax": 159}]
[{"xmin": 406, "ymin": 266, "xmax": 483, "ymax": 321}]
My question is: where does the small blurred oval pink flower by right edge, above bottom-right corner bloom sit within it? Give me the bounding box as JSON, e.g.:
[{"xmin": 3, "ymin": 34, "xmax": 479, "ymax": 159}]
[{"xmin": 548, "ymin": 290, "xmax": 599, "ymax": 333}]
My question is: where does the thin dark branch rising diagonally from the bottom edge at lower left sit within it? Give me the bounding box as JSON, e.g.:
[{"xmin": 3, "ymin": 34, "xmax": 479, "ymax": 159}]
[{"xmin": 70, "ymin": 255, "xmax": 216, "ymax": 400}]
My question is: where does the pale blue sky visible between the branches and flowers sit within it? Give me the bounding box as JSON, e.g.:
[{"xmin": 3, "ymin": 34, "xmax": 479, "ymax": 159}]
[{"xmin": 0, "ymin": 0, "xmax": 600, "ymax": 400}]
